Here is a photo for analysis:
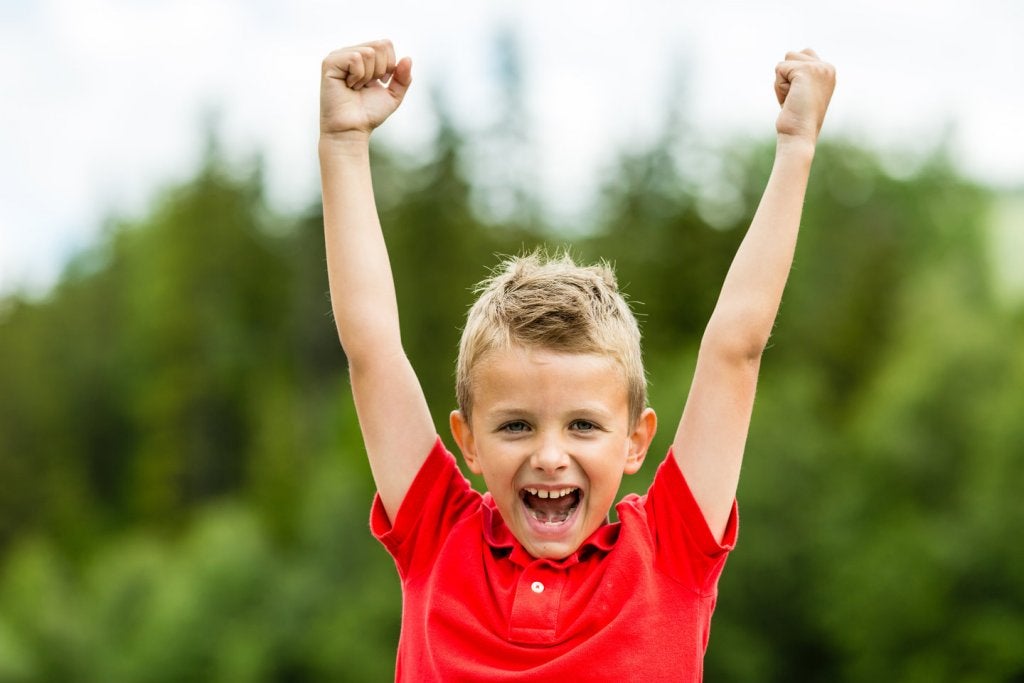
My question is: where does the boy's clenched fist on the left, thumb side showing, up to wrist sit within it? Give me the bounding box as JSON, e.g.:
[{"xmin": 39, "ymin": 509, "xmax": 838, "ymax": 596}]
[{"xmin": 321, "ymin": 40, "xmax": 413, "ymax": 138}]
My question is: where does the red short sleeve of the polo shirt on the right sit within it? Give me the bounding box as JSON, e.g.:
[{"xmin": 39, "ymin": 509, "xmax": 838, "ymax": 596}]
[{"xmin": 644, "ymin": 450, "xmax": 739, "ymax": 594}]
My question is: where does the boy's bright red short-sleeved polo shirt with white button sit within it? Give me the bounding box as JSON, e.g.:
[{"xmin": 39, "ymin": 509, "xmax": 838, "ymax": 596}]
[{"xmin": 371, "ymin": 439, "xmax": 737, "ymax": 683}]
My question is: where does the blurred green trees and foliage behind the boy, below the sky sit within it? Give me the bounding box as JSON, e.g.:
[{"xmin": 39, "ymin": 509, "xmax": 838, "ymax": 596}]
[{"xmin": 0, "ymin": 97, "xmax": 1024, "ymax": 682}]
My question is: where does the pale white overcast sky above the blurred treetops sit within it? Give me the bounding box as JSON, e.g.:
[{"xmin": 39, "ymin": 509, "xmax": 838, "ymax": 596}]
[{"xmin": 0, "ymin": 0, "xmax": 1024, "ymax": 294}]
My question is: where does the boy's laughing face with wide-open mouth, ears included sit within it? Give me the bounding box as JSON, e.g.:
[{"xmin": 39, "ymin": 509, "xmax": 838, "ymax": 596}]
[{"xmin": 452, "ymin": 347, "xmax": 655, "ymax": 559}]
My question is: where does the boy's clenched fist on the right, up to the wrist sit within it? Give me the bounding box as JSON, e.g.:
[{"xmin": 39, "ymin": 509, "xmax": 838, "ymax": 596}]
[{"xmin": 775, "ymin": 49, "xmax": 836, "ymax": 143}]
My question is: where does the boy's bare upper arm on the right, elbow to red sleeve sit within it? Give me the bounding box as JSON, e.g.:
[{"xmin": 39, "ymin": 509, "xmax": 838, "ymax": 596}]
[{"xmin": 673, "ymin": 339, "xmax": 760, "ymax": 541}]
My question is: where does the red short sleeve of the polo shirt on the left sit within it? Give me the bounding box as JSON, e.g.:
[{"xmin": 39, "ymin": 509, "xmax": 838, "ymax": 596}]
[{"xmin": 370, "ymin": 437, "xmax": 481, "ymax": 580}]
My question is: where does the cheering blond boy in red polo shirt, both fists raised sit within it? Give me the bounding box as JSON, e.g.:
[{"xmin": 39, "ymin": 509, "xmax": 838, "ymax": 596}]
[{"xmin": 319, "ymin": 41, "xmax": 835, "ymax": 681}]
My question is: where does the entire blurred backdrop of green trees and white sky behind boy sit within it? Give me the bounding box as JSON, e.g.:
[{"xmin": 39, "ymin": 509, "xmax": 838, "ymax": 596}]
[{"xmin": 0, "ymin": 0, "xmax": 1024, "ymax": 682}]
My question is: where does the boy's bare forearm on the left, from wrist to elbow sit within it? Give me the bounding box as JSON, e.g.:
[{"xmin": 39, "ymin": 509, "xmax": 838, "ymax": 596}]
[{"xmin": 319, "ymin": 136, "xmax": 400, "ymax": 364}]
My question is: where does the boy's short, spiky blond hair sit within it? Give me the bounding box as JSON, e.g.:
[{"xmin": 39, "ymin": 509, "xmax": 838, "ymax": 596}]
[{"xmin": 456, "ymin": 251, "xmax": 647, "ymax": 425}]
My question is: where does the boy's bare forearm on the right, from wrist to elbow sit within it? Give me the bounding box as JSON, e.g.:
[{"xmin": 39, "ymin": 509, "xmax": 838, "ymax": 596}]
[{"xmin": 702, "ymin": 135, "xmax": 814, "ymax": 359}]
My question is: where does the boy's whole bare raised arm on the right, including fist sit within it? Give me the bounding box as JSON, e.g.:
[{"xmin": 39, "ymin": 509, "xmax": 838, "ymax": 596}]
[{"xmin": 673, "ymin": 50, "xmax": 836, "ymax": 539}]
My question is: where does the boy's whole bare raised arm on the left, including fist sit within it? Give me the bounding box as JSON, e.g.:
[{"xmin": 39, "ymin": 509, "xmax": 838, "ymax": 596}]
[{"xmin": 319, "ymin": 40, "xmax": 435, "ymax": 520}]
